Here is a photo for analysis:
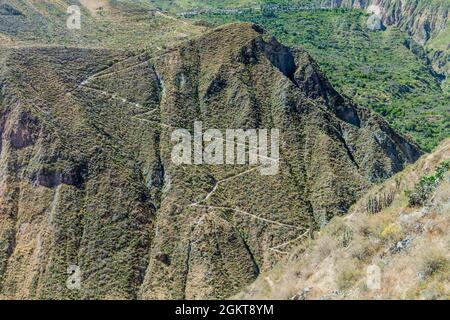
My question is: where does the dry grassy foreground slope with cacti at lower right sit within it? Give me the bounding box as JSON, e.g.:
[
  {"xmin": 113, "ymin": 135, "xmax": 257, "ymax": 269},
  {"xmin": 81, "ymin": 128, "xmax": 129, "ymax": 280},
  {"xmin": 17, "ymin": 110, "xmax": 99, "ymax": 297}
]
[{"xmin": 237, "ymin": 140, "xmax": 450, "ymax": 299}]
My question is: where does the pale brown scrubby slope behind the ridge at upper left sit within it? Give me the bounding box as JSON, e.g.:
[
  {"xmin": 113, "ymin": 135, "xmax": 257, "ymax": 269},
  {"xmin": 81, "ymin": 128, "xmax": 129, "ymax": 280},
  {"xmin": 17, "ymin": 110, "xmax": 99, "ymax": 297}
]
[{"xmin": 0, "ymin": 0, "xmax": 205, "ymax": 51}]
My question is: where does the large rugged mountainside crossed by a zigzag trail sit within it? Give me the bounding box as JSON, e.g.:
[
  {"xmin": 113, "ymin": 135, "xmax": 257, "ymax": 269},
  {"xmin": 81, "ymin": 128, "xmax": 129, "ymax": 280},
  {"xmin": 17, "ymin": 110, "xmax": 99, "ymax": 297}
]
[{"xmin": 0, "ymin": 24, "xmax": 421, "ymax": 299}]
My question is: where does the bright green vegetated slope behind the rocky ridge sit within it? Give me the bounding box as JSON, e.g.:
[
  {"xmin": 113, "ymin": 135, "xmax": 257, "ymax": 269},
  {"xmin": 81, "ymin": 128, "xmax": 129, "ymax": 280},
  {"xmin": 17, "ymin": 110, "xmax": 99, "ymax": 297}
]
[{"xmin": 193, "ymin": 9, "xmax": 450, "ymax": 150}]
